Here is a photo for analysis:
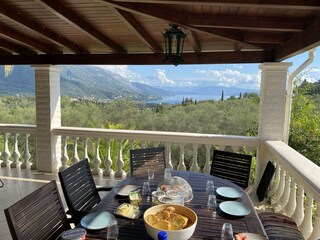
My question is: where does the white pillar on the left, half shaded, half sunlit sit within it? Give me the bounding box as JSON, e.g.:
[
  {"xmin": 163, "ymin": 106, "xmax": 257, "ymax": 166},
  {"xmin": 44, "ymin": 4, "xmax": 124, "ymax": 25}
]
[{"xmin": 33, "ymin": 65, "xmax": 61, "ymax": 172}]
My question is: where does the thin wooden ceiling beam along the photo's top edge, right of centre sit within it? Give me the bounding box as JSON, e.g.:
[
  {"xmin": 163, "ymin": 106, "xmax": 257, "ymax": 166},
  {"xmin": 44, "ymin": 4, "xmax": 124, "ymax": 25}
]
[{"xmin": 114, "ymin": 0, "xmax": 320, "ymax": 10}]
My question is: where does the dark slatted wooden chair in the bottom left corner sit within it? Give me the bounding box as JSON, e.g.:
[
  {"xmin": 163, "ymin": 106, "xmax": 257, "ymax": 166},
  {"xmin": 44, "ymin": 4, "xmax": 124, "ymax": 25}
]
[{"xmin": 4, "ymin": 181, "xmax": 70, "ymax": 240}]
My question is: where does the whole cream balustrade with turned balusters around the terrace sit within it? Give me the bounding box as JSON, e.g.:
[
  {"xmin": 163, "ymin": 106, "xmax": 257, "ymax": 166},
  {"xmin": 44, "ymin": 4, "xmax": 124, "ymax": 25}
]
[{"xmin": 0, "ymin": 124, "xmax": 320, "ymax": 240}]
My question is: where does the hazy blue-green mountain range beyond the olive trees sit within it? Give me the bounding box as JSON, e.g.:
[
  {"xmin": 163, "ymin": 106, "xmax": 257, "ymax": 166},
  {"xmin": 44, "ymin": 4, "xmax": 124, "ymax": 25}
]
[{"xmin": 0, "ymin": 65, "xmax": 258, "ymax": 101}]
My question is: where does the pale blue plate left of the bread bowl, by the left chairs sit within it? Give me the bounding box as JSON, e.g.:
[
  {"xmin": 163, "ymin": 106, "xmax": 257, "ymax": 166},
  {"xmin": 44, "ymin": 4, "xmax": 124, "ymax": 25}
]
[{"xmin": 80, "ymin": 212, "xmax": 114, "ymax": 230}]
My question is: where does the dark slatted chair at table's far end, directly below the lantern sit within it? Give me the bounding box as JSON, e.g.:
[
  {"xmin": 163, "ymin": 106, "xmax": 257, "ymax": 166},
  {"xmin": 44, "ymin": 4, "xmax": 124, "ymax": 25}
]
[{"xmin": 130, "ymin": 147, "xmax": 166, "ymax": 177}]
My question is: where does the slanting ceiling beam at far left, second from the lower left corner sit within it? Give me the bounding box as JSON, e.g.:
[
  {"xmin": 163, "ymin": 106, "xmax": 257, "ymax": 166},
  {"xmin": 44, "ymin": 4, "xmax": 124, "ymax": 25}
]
[{"xmin": 0, "ymin": 23, "xmax": 62, "ymax": 54}]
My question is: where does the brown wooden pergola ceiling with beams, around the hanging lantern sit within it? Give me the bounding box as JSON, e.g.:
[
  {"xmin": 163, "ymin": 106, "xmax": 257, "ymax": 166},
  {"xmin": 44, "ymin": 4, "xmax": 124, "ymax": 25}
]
[{"xmin": 0, "ymin": 0, "xmax": 320, "ymax": 65}]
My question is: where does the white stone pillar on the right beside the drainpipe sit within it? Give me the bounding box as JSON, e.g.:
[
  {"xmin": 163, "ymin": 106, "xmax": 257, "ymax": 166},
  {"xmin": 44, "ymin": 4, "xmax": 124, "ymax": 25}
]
[{"xmin": 256, "ymin": 62, "xmax": 292, "ymax": 183}]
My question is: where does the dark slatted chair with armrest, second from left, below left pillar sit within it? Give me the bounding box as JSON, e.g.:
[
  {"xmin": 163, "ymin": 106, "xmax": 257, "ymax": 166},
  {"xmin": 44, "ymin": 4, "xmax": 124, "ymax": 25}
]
[{"xmin": 58, "ymin": 159, "xmax": 112, "ymax": 223}]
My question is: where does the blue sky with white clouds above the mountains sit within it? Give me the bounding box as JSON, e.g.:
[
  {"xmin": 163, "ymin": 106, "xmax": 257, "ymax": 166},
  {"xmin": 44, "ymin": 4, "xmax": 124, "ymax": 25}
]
[{"xmin": 98, "ymin": 47, "xmax": 320, "ymax": 89}]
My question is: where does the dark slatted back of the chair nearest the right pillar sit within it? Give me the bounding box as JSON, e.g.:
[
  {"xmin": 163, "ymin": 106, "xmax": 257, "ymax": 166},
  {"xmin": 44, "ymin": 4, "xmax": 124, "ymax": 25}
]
[{"xmin": 210, "ymin": 150, "xmax": 252, "ymax": 189}]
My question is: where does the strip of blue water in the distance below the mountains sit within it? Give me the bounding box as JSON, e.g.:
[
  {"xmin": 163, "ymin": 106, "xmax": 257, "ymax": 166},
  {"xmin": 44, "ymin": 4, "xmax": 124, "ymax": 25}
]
[{"xmin": 147, "ymin": 94, "xmax": 230, "ymax": 104}]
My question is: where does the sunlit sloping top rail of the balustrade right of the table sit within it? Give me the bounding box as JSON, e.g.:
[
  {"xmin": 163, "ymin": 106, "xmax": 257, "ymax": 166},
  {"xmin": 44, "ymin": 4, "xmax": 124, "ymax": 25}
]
[{"xmin": 265, "ymin": 141, "xmax": 320, "ymax": 201}]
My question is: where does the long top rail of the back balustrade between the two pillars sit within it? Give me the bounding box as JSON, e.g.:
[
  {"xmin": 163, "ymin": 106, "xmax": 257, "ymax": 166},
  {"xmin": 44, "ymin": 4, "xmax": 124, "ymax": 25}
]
[{"xmin": 52, "ymin": 127, "xmax": 260, "ymax": 147}]
